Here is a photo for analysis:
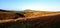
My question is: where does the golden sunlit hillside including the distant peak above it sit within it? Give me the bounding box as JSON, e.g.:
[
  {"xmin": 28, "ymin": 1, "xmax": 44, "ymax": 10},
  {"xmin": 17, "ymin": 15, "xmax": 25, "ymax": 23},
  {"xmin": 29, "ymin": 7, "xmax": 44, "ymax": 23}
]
[{"xmin": 24, "ymin": 10, "xmax": 60, "ymax": 17}]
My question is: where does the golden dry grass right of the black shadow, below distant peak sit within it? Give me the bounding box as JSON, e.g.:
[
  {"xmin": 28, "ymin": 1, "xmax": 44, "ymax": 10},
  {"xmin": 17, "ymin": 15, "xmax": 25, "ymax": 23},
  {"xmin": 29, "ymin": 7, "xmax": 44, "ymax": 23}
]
[{"xmin": 24, "ymin": 12, "xmax": 60, "ymax": 17}]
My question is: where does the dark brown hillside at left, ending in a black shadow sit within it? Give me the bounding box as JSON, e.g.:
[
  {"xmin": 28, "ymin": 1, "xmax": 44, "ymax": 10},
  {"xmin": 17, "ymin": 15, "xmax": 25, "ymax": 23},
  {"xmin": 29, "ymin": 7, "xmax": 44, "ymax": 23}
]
[{"xmin": 0, "ymin": 9, "xmax": 25, "ymax": 20}]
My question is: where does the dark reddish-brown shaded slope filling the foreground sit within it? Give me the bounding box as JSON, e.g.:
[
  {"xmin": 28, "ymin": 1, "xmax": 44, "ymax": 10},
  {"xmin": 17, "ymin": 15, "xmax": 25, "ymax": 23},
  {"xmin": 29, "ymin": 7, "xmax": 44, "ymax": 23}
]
[{"xmin": 1, "ymin": 14, "xmax": 60, "ymax": 28}]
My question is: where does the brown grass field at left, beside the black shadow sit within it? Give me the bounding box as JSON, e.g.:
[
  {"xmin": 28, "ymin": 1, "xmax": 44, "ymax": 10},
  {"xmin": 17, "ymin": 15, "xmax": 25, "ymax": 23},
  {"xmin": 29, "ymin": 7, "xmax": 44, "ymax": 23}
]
[{"xmin": 0, "ymin": 12, "xmax": 16, "ymax": 20}]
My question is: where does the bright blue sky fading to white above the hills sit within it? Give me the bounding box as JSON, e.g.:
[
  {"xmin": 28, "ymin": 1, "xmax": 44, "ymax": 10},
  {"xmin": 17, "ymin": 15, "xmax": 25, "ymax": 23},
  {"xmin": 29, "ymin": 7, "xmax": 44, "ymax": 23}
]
[{"xmin": 0, "ymin": 0, "xmax": 60, "ymax": 11}]
